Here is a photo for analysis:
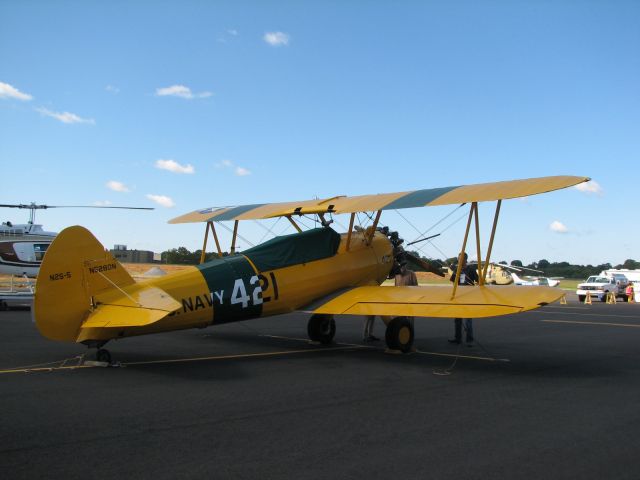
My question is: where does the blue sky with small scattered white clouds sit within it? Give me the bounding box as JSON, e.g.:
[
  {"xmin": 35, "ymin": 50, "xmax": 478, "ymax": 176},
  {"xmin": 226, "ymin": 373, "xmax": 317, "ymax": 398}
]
[{"xmin": 0, "ymin": 0, "xmax": 640, "ymax": 264}]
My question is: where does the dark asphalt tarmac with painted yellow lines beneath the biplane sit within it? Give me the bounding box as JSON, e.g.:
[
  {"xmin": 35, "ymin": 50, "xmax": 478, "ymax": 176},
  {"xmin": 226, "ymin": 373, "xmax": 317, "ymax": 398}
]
[{"xmin": 0, "ymin": 301, "xmax": 640, "ymax": 480}]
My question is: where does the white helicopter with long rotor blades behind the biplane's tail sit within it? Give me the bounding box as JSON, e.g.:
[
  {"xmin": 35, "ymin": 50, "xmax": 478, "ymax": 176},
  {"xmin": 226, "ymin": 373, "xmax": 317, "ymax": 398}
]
[{"xmin": 0, "ymin": 203, "xmax": 153, "ymax": 277}]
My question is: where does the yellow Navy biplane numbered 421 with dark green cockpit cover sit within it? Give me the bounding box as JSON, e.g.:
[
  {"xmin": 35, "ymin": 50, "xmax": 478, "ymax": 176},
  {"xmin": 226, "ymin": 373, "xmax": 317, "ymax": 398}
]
[{"xmin": 34, "ymin": 176, "xmax": 589, "ymax": 361}]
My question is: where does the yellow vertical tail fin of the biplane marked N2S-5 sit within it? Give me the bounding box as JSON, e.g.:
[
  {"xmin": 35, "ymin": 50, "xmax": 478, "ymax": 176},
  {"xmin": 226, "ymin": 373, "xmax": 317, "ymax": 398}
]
[{"xmin": 33, "ymin": 226, "xmax": 135, "ymax": 341}]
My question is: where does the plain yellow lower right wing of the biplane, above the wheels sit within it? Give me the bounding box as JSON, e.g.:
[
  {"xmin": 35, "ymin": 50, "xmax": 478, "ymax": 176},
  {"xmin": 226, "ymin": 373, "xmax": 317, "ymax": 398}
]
[{"xmin": 314, "ymin": 285, "xmax": 564, "ymax": 318}]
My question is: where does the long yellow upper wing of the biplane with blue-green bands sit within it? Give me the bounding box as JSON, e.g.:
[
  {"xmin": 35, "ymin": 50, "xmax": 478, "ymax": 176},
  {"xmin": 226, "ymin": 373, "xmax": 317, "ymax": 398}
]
[{"xmin": 169, "ymin": 176, "xmax": 590, "ymax": 223}]
